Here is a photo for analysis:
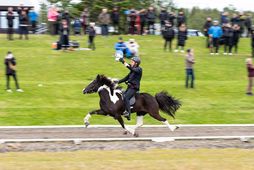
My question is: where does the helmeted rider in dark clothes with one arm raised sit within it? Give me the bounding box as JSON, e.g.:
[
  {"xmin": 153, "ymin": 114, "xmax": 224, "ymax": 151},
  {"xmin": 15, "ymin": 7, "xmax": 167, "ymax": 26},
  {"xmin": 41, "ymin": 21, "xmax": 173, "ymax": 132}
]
[{"xmin": 118, "ymin": 57, "xmax": 142, "ymax": 120}]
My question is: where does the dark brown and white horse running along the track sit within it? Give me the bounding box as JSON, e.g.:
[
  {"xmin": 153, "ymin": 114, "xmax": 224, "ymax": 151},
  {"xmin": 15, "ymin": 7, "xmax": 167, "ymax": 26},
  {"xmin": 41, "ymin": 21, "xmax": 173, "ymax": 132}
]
[{"xmin": 83, "ymin": 74, "xmax": 181, "ymax": 137}]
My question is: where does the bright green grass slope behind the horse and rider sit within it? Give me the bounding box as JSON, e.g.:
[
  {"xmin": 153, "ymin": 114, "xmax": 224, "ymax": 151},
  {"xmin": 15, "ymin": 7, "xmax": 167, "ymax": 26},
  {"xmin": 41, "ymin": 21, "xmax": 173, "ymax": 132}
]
[{"xmin": 0, "ymin": 35, "xmax": 254, "ymax": 125}]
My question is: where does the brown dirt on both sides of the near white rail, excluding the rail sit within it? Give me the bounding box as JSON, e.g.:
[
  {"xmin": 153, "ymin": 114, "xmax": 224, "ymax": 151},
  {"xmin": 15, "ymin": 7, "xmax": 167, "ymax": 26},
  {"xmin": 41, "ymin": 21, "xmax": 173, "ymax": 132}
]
[{"xmin": 0, "ymin": 126, "xmax": 254, "ymax": 152}]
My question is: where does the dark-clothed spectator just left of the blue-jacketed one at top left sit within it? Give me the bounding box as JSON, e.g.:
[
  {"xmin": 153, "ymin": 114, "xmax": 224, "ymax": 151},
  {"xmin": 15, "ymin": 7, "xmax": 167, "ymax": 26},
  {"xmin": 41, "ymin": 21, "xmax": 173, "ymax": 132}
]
[{"xmin": 19, "ymin": 10, "xmax": 29, "ymax": 40}]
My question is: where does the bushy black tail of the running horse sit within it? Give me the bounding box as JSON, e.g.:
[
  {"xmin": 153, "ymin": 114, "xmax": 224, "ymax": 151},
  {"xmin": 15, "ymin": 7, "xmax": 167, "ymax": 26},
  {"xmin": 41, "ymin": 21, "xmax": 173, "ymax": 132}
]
[{"xmin": 155, "ymin": 91, "xmax": 181, "ymax": 118}]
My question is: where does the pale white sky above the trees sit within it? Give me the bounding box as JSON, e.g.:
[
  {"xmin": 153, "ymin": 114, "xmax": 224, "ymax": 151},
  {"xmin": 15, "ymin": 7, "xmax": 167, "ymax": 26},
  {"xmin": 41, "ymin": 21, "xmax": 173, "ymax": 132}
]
[{"xmin": 30, "ymin": 0, "xmax": 254, "ymax": 11}]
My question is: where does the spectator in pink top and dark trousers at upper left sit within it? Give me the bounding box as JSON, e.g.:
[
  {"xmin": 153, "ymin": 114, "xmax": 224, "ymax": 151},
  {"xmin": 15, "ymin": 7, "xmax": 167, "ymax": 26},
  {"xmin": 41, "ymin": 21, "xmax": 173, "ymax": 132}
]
[{"xmin": 48, "ymin": 7, "xmax": 59, "ymax": 35}]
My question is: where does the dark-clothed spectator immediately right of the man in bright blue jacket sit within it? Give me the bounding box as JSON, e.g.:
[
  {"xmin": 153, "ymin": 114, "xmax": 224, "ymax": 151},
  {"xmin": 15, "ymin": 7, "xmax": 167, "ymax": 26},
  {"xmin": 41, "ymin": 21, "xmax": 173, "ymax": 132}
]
[{"xmin": 223, "ymin": 23, "xmax": 234, "ymax": 55}]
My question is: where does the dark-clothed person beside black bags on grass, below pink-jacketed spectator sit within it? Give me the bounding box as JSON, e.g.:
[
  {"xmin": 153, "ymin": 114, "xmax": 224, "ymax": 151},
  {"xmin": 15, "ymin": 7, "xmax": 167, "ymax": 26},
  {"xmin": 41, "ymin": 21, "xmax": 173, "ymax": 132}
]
[{"xmin": 60, "ymin": 19, "xmax": 70, "ymax": 50}]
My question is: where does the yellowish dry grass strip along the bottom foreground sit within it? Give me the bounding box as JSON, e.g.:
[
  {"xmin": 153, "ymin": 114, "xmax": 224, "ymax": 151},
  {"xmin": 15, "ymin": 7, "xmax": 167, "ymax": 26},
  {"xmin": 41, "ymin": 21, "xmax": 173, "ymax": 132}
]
[{"xmin": 0, "ymin": 149, "xmax": 254, "ymax": 170}]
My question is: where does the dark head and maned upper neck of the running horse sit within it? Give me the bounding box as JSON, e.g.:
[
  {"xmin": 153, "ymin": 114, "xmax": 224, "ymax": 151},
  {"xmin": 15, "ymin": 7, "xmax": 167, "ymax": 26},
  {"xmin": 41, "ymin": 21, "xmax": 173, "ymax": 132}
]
[{"xmin": 83, "ymin": 74, "xmax": 115, "ymax": 95}]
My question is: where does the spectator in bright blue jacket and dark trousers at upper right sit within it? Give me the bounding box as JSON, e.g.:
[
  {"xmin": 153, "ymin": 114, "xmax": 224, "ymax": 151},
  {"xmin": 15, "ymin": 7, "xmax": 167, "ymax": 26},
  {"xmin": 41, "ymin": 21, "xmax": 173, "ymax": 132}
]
[{"xmin": 208, "ymin": 20, "xmax": 222, "ymax": 55}]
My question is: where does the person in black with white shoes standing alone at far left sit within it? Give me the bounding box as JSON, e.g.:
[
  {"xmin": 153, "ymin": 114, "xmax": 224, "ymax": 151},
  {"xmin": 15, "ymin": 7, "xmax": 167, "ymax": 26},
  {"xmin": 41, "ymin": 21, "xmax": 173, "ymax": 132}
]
[{"xmin": 4, "ymin": 51, "xmax": 24, "ymax": 93}]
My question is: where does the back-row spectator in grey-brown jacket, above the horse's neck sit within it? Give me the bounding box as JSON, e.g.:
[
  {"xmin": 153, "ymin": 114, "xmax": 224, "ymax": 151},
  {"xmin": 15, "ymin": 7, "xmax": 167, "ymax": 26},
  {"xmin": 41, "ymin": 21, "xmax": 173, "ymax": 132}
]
[{"xmin": 98, "ymin": 8, "xmax": 110, "ymax": 36}]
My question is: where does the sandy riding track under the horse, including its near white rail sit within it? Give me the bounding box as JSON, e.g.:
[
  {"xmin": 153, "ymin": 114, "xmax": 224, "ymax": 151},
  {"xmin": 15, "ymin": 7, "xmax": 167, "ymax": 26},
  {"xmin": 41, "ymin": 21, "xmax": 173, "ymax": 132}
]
[{"xmin": 0, "ymin": 124, "xmax": 254, "ymax": 152}]
